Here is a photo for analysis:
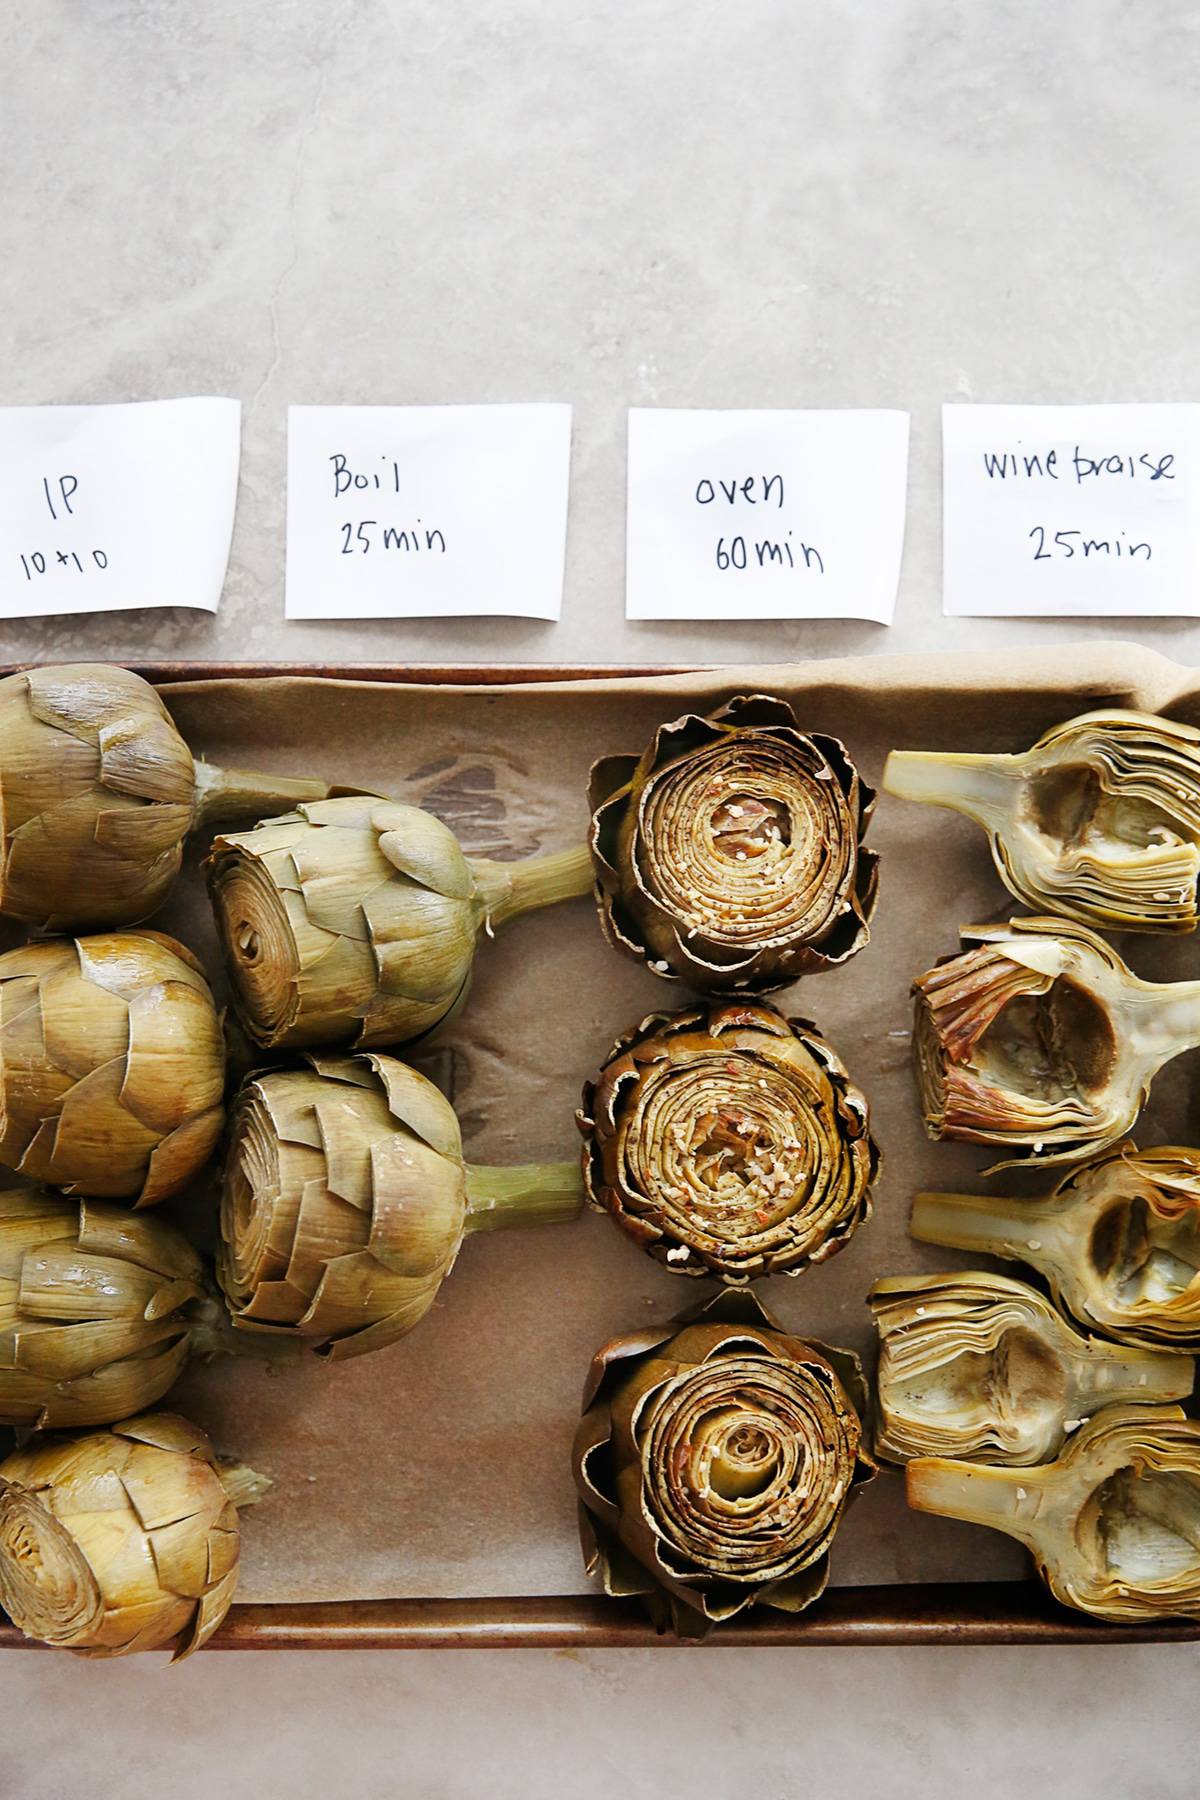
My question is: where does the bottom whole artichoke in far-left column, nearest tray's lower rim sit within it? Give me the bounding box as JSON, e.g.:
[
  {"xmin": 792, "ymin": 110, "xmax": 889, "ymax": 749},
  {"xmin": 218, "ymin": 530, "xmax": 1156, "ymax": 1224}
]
[{"xmin": 0, "ymin": 1413, "xmax": 270, "ymax": 1661}]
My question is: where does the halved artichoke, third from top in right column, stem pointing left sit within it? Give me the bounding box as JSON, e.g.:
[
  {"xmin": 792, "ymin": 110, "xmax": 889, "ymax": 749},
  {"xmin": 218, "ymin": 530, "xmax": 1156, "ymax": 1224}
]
[{"xmin": 912, "ymin": 1143, "xmax": 1200, "ymax": 1352}]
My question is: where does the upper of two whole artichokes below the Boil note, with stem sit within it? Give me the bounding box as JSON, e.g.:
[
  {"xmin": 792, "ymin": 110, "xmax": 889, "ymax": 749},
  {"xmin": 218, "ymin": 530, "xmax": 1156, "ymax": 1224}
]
[{"xmin": 209, "ymin": 797, "xmax": 592, "ymax": 1048}]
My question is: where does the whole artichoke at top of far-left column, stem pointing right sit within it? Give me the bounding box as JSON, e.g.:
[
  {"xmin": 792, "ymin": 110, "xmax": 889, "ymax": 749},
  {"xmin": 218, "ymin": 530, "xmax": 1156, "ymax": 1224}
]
[{"xmin": 0, "ymin": 662, "xmax": 338, "ymax": 932}]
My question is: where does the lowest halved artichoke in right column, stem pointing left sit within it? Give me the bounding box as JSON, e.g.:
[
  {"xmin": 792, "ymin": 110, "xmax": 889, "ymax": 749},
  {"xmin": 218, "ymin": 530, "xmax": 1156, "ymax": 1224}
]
[{"xmin": 907, "ymin": 1406, "xmax": 1200, "ymax": 1624}]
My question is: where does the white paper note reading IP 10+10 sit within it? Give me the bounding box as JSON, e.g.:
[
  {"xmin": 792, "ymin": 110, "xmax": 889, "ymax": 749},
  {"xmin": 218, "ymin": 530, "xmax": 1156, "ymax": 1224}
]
[{"xmin": 0, "ymin": 398, "xmax": 241, "ymax": 619}]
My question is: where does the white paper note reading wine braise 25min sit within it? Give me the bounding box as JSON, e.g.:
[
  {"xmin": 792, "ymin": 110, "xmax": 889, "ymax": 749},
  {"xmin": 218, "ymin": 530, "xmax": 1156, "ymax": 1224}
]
[{"xmin": 943, "ymin": 405, "xmax": 1200, "ymax": 617}]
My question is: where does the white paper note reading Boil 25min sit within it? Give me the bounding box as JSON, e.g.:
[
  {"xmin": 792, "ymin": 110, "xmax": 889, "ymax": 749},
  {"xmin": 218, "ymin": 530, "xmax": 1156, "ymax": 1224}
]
[{"xmin": 286, "ymin": 405, "xmax": 570, "ymax": 619}]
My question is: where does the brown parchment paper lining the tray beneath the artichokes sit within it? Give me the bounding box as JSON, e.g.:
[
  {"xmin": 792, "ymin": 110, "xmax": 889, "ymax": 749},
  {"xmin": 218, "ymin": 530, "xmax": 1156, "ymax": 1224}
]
[{"xmin": 135, "ymin": 644, "xmax": 1200, "ymax": 1602}]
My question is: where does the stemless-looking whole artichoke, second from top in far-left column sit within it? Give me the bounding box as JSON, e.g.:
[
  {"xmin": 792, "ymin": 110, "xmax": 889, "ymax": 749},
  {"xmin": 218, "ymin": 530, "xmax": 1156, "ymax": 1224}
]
[{"xmin": 0, "ymin": 931, "xmax": 225, "ymax": 1206}]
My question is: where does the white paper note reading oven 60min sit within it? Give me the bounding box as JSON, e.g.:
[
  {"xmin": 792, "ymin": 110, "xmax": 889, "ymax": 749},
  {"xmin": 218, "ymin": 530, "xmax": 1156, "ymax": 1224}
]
[{"xmin": 624, "ymin": 407, "xmax": 909, "ymax": 625}]
